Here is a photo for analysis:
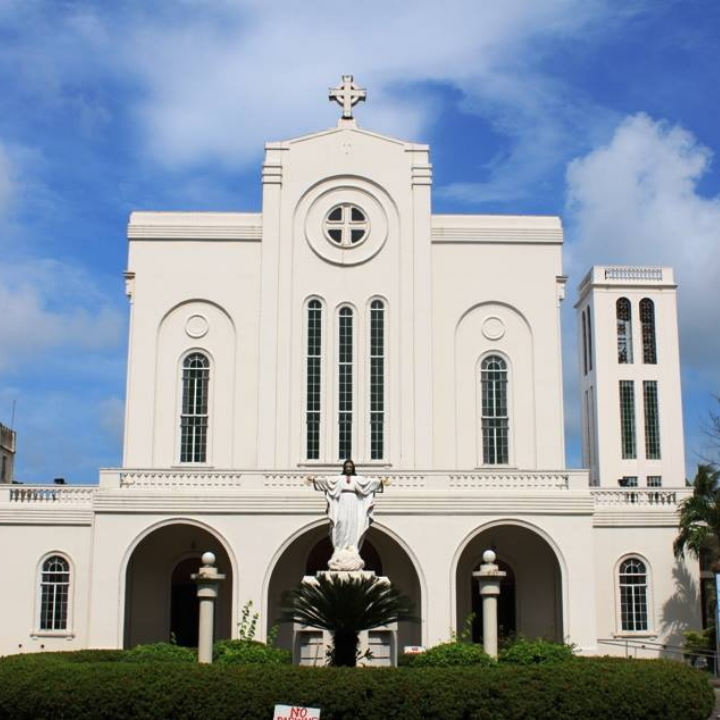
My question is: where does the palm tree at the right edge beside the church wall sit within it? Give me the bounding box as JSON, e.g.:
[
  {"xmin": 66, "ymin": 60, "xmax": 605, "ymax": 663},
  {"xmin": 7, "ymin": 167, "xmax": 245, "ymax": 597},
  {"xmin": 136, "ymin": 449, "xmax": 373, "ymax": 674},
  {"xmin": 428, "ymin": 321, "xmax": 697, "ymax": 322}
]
[{"xmin": 673, "ymin": 464, "xmax": 720, "ymax": 557}]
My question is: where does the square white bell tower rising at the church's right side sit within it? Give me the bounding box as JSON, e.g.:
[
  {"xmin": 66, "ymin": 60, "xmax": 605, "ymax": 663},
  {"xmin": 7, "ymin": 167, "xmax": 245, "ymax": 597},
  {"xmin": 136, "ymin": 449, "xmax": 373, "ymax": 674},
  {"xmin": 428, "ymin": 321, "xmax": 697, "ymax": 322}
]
[{"xmin": 575, "ymin": 266, "xmax": 685, "ymax": 487}]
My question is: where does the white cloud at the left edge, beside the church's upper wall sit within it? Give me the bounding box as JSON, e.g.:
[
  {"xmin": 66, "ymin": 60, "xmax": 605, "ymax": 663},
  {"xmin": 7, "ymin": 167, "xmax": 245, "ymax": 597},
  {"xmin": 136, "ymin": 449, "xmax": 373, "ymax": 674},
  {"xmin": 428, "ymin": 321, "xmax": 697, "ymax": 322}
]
[{"xmin": 0, "ymin": 259, "xmax": 124, "ymax": 370}]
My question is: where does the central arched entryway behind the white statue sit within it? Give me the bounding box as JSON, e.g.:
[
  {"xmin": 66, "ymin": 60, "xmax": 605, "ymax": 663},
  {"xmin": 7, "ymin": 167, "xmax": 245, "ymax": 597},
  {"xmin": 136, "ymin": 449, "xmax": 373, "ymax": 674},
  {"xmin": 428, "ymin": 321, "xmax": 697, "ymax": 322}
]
[{"xmin": 267, "ymin": 524, "xmax": 422, "ymax": 652}]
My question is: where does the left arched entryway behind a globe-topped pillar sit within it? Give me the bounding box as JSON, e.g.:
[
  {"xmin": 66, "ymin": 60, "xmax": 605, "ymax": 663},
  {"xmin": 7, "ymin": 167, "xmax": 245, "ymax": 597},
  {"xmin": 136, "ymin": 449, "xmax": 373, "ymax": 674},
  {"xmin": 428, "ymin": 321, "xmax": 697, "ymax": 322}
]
[{"xmin": 124, "ymin": 523, "xmax": 233, "ymax": 648}]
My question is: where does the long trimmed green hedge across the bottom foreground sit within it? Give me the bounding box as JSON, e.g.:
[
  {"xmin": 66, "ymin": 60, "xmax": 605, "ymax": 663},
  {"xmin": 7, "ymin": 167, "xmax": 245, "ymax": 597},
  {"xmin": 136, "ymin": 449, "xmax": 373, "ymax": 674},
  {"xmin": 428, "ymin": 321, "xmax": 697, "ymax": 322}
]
[{"xmin": 0, "ymin": 653, "xmax": 714, "ymax": 720}]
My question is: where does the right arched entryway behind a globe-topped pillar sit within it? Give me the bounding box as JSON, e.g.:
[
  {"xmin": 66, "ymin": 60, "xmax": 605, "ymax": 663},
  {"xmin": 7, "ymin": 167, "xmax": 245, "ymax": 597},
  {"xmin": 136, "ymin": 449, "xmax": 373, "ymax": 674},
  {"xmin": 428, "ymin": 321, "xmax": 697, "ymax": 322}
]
[{"xmin": 456, "ymin": 524, "xmax": 563, "ymax": 642}]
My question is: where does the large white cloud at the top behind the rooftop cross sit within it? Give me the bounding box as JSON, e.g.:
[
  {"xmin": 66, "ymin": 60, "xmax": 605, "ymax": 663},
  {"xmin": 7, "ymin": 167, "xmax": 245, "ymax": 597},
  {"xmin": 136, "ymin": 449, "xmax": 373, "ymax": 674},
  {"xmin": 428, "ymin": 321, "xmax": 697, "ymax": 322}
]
[{"xmin": 115, "ymin": 0, "xmax": 618, "ymax": 179}]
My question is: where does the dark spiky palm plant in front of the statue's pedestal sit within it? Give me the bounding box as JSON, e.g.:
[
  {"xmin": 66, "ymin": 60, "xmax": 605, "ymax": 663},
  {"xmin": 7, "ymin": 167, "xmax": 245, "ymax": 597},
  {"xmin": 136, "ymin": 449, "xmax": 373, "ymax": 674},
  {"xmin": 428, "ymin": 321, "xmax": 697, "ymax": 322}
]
[{"xmin": 280, "ymin": 574, "xmax": 416, "ymax": 667}]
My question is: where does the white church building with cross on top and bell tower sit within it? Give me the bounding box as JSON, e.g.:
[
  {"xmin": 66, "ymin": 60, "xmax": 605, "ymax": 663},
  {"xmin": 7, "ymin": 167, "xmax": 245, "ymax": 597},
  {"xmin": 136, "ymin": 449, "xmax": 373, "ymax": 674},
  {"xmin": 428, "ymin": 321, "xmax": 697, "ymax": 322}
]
[{"xmin": 0, "ymin": 78, "xmax": 700, "ymax": 654}]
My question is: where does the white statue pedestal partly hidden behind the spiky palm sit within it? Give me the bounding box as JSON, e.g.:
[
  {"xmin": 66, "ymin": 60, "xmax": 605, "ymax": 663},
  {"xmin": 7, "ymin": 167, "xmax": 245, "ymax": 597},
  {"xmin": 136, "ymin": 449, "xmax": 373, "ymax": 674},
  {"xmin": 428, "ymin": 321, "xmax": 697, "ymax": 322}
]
[{"xmin": 293, "ymin": 570, "xmax": 397, "ymax": 667}]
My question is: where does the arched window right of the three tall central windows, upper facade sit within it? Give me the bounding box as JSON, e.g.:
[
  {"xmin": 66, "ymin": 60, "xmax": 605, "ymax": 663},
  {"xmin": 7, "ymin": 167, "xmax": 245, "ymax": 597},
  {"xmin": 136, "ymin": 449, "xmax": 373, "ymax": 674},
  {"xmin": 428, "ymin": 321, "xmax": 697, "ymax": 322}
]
[{"xmin": 480, "ymin": 355, "xmax": 510, "ymax": 465}]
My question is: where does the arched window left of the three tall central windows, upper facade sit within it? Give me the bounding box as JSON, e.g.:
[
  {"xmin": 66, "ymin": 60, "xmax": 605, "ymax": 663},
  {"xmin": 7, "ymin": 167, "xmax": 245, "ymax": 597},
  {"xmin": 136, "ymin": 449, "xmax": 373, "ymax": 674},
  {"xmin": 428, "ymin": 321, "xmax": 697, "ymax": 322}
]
[{"xmin": 180, "ymin": 352, "xmax": 210, "ymax": 462}]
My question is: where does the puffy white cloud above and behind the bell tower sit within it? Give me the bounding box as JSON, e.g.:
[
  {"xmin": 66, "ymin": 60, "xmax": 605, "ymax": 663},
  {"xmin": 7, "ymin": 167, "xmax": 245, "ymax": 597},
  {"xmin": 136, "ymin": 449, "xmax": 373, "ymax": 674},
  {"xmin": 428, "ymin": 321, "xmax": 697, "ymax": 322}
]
[{"xmin": 567, "ymin": 114, "xmax": 720, "ymax": 381}]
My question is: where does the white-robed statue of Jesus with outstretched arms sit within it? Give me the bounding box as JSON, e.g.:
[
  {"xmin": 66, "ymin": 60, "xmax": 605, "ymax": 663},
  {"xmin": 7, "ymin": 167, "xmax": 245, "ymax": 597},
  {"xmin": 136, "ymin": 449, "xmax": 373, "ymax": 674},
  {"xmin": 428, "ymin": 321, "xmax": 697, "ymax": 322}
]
[{"xmin": 307, "ymin": 460, "xmax": 390, "ymax": 571}]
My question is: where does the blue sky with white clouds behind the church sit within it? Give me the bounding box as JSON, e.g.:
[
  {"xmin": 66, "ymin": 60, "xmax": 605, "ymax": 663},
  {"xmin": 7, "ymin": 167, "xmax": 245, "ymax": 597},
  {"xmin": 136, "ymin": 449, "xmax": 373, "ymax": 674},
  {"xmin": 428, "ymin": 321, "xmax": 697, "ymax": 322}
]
[{"xmin": 0, "ymin": 0, "xmax": 720, "ymax": 482}]
